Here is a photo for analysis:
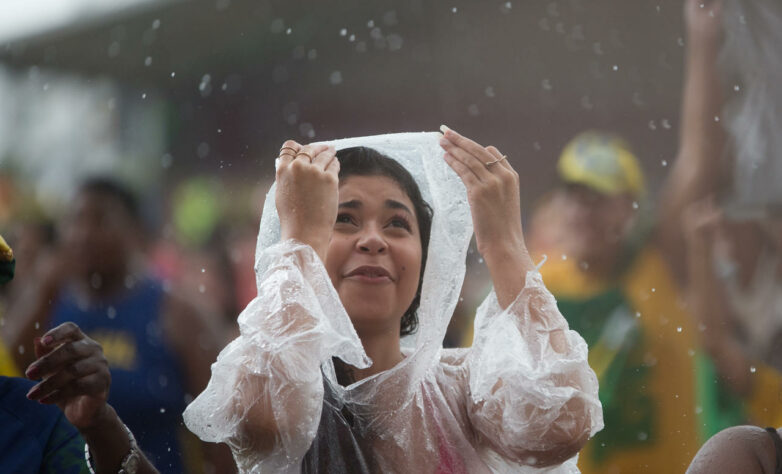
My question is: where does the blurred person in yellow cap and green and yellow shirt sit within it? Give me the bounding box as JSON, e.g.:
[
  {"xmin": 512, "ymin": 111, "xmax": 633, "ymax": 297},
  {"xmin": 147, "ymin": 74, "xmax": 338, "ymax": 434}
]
[{"xmin": 529, "ymin": 131, "xmax": 699, "ymax": 473}]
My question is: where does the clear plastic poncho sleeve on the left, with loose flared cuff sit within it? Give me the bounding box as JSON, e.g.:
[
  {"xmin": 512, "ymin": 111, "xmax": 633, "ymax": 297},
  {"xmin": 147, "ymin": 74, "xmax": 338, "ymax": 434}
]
[{"xmin": 184, "ymin": 241, "xmax": 370, "ymax": 472}]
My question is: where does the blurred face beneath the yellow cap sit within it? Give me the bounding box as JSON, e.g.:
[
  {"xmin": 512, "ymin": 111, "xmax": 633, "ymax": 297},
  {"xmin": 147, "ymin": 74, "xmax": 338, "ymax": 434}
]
[{"xmin": 550, "ymin": 184, "xmax": 635, "ymax": 266}]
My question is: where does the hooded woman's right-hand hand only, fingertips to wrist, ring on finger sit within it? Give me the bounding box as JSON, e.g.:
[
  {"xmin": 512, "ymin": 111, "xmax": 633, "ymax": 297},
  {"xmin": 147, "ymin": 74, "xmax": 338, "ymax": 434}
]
[{"xmin": 440, "ymin": 127, "xmax": 526, "ymax": 258}]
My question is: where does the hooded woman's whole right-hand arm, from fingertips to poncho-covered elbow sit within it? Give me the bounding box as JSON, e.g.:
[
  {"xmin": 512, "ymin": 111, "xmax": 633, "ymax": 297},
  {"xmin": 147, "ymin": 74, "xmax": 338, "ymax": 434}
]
[{"xmin": 440, "ymin": 127, "xmax": 602, "ymax": 467}]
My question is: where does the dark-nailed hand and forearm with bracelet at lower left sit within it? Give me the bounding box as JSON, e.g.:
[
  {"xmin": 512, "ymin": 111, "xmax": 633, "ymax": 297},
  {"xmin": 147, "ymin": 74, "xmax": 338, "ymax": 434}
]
[{"xmin": 26, "ymin": 323, "xmax": 158, "ymax": 474}]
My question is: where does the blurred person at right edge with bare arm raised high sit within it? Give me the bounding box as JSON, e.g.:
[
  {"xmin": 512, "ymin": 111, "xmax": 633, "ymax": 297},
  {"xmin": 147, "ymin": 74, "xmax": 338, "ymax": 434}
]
[{"xmin": 662, "ymin": 1, "xmax": 782, "ymax": 446}]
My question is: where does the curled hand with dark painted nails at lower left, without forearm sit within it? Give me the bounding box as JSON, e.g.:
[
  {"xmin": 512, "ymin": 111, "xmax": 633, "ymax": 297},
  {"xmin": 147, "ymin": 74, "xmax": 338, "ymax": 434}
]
[{"xmin": 26, "ymin": 323, "xmax": 111, "ymax": 430}]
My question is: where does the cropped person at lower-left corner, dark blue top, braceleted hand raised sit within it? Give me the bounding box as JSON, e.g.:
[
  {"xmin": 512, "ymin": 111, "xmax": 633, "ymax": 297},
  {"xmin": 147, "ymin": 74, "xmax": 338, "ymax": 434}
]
[{"xmin": 0, "ymin": 235, "xmax": 157, "ymax": 474}]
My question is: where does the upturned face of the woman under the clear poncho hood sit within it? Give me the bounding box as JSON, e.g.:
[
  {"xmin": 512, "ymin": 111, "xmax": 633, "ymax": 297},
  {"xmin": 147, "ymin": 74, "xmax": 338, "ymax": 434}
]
[{"xmin": 326, "ymin": 176, "xmax": 421, "ymax": 334}]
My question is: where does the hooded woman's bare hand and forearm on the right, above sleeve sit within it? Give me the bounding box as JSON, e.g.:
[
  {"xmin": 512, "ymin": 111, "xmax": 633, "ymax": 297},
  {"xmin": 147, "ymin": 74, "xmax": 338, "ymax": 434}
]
[{"xmin": 440, "ymin": 125, "xmax": 534, "ymax": 307}]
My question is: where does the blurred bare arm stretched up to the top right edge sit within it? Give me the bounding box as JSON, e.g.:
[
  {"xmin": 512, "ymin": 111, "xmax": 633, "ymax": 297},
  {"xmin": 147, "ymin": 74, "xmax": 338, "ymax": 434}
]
[{"xmin": 655, "ymin": 0, "xmax": 728, "ymax": 282}]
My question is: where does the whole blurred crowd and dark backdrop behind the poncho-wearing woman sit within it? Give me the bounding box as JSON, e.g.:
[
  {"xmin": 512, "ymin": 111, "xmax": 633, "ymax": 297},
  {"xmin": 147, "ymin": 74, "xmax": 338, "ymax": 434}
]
[{"xmin": 0, "ymin": 0, "xmax": 782, "ymax": 473}]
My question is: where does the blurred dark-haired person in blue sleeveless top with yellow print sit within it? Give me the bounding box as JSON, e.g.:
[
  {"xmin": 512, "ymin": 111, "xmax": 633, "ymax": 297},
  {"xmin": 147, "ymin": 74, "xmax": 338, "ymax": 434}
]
[{"xmin": 6, "ymin": 178, "xmax": 233, "ymax": 472}]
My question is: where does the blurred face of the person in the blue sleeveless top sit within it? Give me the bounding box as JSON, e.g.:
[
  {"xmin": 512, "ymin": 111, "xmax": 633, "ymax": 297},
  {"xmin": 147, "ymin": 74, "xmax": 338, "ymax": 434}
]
[{"xmin": 63, "ymin": 192, "xmax": 136, "ymax": 278}]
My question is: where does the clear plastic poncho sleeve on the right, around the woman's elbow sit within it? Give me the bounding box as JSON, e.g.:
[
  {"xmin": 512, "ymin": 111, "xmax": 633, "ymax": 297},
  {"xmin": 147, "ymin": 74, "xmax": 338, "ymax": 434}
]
[{"xmin": 466, "ymin": 272, "xmax": 603, "ymax": 466}]
